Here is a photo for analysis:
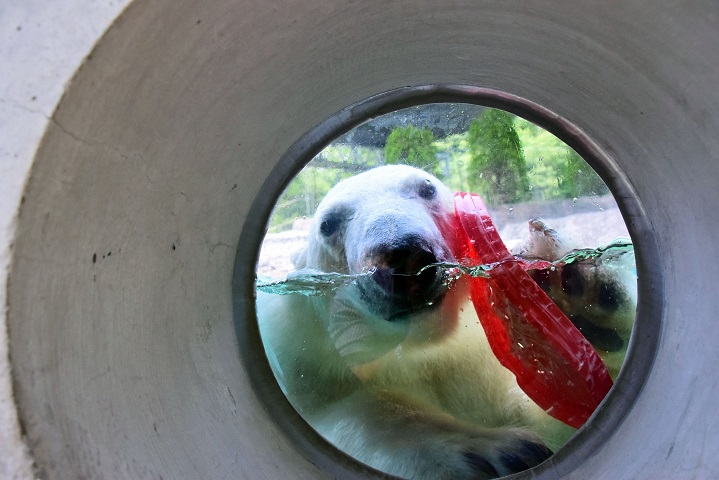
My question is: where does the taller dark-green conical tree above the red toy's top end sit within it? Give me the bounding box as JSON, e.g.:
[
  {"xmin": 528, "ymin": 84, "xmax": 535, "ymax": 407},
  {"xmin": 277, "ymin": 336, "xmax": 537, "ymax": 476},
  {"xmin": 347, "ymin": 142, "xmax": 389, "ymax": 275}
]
[{"xmin": 467, "ymin": 108, "xmax": 529, "ymax": 204}]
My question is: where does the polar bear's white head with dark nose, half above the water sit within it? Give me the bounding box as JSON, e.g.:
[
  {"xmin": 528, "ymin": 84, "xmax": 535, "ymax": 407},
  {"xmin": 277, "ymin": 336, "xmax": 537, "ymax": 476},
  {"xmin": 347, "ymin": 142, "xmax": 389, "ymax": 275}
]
[{"xmin": 295, "ymin": 165, "xmax": 454, "ymax": 320}]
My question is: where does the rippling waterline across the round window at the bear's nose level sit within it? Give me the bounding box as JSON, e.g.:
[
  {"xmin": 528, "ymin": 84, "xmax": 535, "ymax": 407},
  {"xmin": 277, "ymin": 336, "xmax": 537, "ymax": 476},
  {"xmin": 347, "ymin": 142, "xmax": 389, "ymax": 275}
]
[{"xmin": 256, "ymin": 238, "xmax": 636, "ymax": 296}]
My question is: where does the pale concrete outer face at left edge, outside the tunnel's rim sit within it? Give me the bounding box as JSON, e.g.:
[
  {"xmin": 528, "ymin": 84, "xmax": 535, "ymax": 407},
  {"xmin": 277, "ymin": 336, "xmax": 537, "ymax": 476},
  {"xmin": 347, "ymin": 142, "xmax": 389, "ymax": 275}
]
[{"xmin": 0, "ymin": 0, "xmax": 129, "ymax": 479}]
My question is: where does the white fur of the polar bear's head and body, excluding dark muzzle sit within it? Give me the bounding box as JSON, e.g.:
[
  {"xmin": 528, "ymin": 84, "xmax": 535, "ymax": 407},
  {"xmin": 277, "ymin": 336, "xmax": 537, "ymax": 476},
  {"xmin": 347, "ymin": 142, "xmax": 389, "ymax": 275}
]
[{"xmin": 257, "ymin": 166, "xmax": 608, "ymax": 479}]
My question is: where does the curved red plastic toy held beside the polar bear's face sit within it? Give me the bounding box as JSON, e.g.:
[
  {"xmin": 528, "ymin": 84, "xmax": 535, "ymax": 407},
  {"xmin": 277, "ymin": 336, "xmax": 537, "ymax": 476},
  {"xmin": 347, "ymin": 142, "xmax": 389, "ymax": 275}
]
[{"xmin": 455, "ymin": 192, "xmax": 612, "ymax": 428}]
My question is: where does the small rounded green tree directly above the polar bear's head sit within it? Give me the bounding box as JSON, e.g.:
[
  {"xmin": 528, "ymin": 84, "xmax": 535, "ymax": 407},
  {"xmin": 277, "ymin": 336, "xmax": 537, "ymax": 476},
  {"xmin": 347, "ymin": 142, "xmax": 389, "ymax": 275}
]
[{"xmin": 384, "ymin": 125, "xmax": 440, "ymax": 174}]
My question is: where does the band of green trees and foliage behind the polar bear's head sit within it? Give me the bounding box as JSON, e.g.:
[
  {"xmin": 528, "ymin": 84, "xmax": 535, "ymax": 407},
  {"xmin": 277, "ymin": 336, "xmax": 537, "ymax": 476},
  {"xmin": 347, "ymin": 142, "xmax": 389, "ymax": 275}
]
[{"xmin": 270, "ymin": 108, "xmax": 609, "ymax": 232}]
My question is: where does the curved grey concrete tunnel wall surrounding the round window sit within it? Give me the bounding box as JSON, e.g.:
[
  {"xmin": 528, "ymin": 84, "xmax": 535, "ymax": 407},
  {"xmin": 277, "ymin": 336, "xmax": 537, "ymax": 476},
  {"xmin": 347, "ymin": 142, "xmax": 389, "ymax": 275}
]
[{"xmin": 1, "ymin": 0, "xmax": 719, "ymax": 479}]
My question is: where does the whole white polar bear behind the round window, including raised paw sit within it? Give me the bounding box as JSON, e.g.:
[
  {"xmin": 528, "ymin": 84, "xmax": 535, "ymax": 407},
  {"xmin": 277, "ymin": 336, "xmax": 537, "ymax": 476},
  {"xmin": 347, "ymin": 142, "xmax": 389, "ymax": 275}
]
[{"xmin": 257, "ymin": 165, "xmax": 633, "ymax": 479}]
